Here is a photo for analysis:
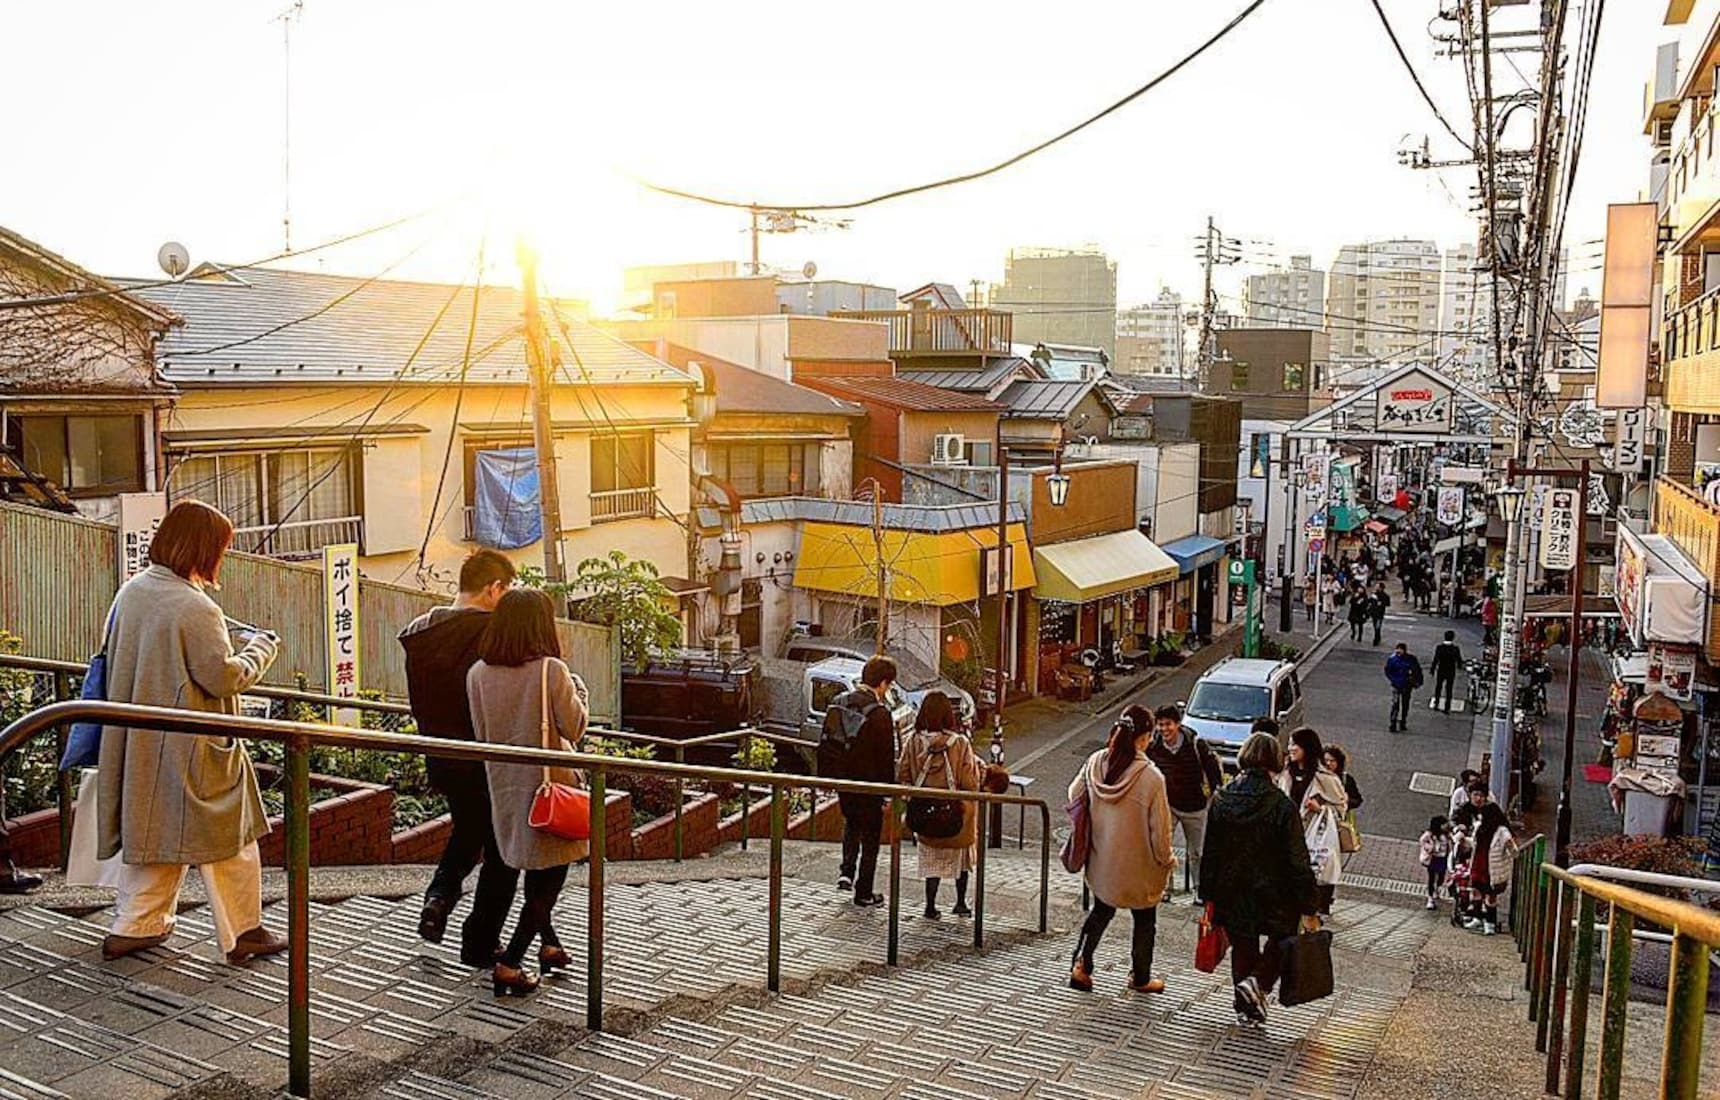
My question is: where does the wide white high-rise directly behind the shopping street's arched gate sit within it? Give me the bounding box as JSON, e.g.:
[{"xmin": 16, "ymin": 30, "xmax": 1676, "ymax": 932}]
[{"xmin": 1326, "ymin": 239, "xmax": 1441, "ymax": 363}]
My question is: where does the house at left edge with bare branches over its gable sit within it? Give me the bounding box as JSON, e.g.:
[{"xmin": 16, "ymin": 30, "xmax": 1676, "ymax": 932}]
[{"xmin": 0, "ymin": 229, "xmax": 179, "ymax": 521}]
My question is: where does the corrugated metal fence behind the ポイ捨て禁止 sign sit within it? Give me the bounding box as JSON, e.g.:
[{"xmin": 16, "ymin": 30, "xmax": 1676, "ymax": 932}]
[{"xmin": 0, "ymin": 502, "xmax": 621, "ymax": 724}]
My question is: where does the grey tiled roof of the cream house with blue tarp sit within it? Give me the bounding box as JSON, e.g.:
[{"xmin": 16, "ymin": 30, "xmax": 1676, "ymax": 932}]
[{"xmin": 132, "ymin": 268, "xmax": 691, "ymax": 385}]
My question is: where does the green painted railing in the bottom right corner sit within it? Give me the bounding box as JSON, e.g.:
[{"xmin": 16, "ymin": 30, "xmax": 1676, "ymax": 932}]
[{"xmin": 1510, "ymin": 837, "xmax": 1720, "ymax": 1100}]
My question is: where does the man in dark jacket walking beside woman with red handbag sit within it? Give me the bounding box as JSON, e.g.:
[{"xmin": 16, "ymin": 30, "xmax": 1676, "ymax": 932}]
[{"xmin": 401, "ymin": 550, "xmax": 519, "ymax": 966}]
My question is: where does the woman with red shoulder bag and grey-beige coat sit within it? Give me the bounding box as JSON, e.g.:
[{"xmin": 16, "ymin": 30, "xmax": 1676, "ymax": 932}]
[{"xmin": 466, "ymin": 588, "xmax": 592, "ymax": 997}]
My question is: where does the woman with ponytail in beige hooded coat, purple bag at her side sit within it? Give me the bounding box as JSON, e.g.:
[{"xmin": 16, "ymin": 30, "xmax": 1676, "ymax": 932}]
[{"xmin": 1070, "ymin": 715, "xmax": 1176, "ymax": 993}]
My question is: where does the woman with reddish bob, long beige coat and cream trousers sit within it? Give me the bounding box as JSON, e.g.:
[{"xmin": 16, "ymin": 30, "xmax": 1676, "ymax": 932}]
[{"xmin": 96, "ymin": 500, "xmax": 287, "ymax": 963}]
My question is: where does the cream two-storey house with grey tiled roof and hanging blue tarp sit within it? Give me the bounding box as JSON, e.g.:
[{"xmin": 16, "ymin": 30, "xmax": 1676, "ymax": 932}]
[{"xmin": 136, "ymin": 266, "xmax": 695, "ymax": 588}]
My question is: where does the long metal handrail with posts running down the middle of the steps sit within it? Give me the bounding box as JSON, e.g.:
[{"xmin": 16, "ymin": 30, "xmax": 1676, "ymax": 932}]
[{"xmin": 0, "ymin": 700, "xmax": 1051, "ymax": 1097}]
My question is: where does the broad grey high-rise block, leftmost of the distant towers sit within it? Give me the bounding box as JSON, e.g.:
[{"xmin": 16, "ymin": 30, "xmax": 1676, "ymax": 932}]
[{"xmin": 991, "ymin": 248, "xmax": 1116, "ymax": 358}]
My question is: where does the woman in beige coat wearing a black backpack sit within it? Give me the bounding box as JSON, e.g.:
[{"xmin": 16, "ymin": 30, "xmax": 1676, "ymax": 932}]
[{"xmin": 896, "ymin": 691, "xmax": 986, "ymax": 921}]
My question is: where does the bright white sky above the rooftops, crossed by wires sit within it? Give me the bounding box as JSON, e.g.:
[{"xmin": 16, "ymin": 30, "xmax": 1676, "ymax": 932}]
[{"xmin": 0, "ymin": 0, "xmax": 1672, "ymax": 312}]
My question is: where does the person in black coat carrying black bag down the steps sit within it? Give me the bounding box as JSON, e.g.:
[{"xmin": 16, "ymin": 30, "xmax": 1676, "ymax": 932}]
[{"xmin": 1201, "ymin": 732, "xmax": 1319, "ymax": 1024}]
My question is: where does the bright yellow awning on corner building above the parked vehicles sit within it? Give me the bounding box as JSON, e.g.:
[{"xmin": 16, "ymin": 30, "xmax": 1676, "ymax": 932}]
[{"xmin": 795, "ymin": 523, "xmax": 1037, "ymax": 607}]
